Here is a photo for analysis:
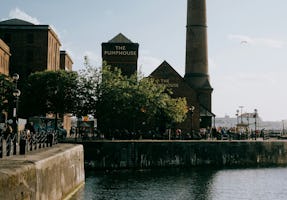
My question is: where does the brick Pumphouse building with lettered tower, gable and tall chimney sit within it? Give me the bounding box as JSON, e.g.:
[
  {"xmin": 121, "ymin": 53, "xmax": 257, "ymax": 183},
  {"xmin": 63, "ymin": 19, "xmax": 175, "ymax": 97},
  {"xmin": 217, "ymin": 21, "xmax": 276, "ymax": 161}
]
[{"xmin": 102, "ymin": 0, "xmax": 215, "ymax": 132}]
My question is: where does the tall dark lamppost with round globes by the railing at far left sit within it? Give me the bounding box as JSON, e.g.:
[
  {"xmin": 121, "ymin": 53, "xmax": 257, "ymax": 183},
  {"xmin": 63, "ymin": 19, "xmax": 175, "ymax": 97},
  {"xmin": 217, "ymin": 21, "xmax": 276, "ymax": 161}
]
[{"xmin": 12, "ymin": 73, "xmax": 21, "ymax": 155}]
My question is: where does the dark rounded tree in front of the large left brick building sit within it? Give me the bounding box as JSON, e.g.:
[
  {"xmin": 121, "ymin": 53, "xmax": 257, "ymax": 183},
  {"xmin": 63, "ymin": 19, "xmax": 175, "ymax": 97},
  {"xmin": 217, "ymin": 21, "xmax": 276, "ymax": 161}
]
[{"xmin": 20, "ymin": 70, "xmax": 78, "ymax": 117}]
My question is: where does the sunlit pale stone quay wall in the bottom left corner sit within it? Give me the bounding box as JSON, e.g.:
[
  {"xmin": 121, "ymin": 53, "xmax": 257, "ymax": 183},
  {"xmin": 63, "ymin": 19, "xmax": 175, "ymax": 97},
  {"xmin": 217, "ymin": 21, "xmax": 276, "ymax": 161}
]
[{"xmin": 0, "ymin": 144, "xmax": 85, "ymax": 200}]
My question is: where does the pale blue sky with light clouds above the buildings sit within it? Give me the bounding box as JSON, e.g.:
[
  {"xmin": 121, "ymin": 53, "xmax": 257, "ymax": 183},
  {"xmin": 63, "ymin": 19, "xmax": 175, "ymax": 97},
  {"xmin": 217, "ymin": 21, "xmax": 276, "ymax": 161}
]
[{"xmin": 0, "ymin": 0, "xmax": 287, "ymax": 121}]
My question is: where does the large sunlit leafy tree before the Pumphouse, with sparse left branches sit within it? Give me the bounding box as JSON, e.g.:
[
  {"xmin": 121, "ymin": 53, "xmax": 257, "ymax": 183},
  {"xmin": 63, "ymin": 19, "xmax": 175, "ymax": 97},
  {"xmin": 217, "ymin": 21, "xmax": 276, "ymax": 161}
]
[{"xmin": 74, "ymin": 57, "xmax": 188, "ymax": 134}]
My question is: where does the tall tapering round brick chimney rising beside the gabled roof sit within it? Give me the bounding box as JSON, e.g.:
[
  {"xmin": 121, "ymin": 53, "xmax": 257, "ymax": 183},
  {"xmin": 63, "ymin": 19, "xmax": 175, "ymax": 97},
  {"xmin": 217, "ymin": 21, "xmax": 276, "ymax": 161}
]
[{"xmin": 185, "ymin": 0, "xmax": 212, "ymax": 89}]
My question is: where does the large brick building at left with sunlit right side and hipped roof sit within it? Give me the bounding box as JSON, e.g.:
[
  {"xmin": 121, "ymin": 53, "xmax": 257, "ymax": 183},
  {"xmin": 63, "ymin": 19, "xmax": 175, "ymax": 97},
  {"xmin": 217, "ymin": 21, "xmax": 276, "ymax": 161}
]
[{"xmin": 0, "ymin": 19, "xmax": 61, "ymax": 83}]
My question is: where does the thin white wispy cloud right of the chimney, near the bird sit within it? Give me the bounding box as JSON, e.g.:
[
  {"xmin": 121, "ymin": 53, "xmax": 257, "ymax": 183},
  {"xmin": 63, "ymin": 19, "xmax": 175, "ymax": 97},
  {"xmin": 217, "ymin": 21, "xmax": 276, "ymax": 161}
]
[{"xmin": 228, "ymin": 34, "xmax": 286, "ymax": 48}]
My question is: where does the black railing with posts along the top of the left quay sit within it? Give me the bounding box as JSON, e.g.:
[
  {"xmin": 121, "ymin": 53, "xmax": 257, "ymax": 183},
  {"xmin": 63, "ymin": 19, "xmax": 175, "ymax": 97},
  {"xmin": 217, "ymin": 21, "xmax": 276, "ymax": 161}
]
[{"xmin": 0, "ymin": 130, "xmax": 59, "ymax": 158}]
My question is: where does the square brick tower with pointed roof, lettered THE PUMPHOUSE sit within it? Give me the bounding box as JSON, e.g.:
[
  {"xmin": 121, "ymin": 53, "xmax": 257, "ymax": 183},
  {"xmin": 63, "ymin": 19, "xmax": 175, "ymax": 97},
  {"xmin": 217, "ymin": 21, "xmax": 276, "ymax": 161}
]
[{"xmin": 102, "ymin": 33, "xmax": 139, "ymax": 76}]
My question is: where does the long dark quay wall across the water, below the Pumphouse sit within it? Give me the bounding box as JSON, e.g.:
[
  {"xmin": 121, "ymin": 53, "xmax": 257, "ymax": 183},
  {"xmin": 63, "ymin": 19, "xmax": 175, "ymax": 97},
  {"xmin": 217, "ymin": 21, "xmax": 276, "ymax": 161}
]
[{"xmin": 83, "ymin": 140, "xmax": 287, "ymax": 170}]
